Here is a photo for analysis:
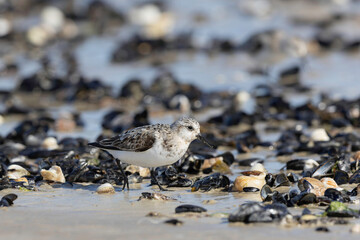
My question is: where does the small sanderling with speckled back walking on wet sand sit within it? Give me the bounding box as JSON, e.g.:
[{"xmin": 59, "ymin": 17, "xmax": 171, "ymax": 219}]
[{"xmin": 89, "ymin": 117, "xmax": 211, "ymax": 190}]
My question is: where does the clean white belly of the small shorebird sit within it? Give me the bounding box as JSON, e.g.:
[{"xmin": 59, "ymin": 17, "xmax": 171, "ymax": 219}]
[{"xmin": 107, "ymin": 147, "xmax": 181, "ymax": 167}]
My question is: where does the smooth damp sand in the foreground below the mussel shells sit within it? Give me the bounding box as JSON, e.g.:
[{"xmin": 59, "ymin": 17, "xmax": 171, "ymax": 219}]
[{"xmin": 0, "ymin": 180, "xmax": 360, "ymax": 239}]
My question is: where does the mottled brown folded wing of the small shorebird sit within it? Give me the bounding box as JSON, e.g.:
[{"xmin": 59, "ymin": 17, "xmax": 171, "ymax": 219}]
[{"xmin": 99, "ymin": 127, "xmax": 155, "ymax": 152}]
